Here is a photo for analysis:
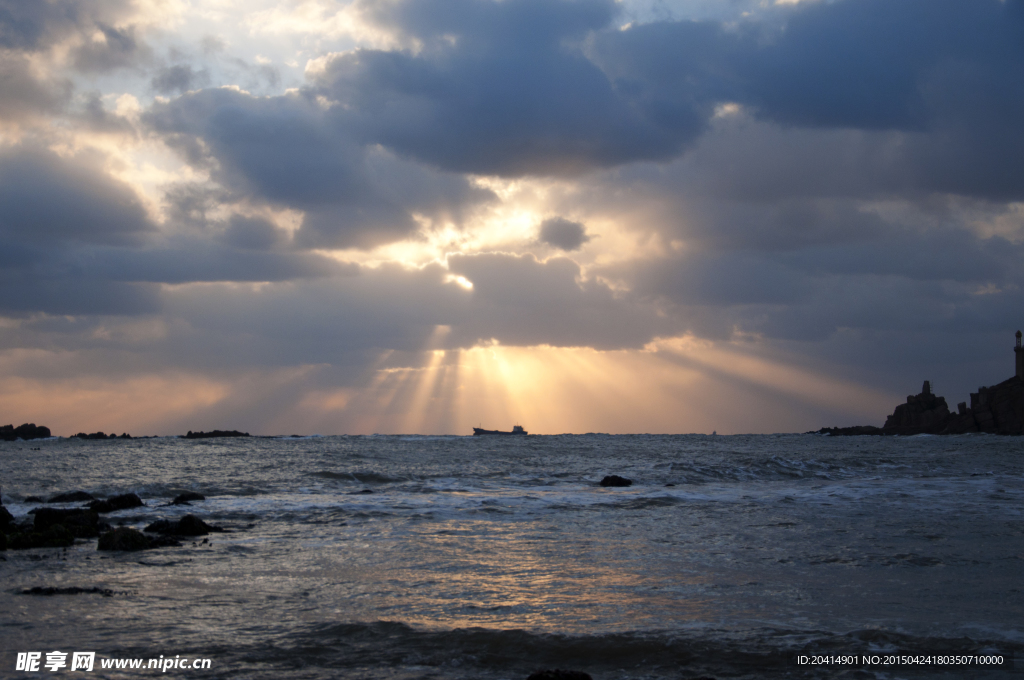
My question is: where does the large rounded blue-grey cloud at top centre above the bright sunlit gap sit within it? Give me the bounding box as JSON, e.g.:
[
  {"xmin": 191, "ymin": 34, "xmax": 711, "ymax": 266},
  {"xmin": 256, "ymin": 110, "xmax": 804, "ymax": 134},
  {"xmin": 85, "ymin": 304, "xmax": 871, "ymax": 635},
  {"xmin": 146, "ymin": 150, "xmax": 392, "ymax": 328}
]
[{"xmin": 315, "ymin": 0, "xmax": 702, "ymax": 176}]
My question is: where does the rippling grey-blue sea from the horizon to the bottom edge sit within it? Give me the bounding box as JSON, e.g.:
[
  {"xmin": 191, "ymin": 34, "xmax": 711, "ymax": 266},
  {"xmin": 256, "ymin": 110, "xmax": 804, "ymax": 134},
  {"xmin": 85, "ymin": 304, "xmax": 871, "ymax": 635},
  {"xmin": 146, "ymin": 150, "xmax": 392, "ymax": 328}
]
[{"xmin": 0, "ymin": 434, "xmax": 1024, "ymax": 680}]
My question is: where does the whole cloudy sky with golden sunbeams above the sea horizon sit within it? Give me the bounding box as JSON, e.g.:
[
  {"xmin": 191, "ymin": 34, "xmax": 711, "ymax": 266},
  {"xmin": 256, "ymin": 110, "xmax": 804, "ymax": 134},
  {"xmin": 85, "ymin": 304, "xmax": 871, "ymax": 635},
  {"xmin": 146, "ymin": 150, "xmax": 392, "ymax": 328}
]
[{"xmin": 0, "ymin": 0, "xmax": 1024, "ymax": 436}]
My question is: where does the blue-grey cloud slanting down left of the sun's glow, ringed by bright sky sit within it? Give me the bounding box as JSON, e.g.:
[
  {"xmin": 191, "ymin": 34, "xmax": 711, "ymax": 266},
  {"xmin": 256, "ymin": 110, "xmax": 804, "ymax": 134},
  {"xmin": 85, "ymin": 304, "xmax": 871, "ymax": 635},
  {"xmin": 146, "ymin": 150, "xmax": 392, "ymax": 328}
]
[{"xmin": 145, "ymin": 89, "xmax": 492, "ymax": 247}]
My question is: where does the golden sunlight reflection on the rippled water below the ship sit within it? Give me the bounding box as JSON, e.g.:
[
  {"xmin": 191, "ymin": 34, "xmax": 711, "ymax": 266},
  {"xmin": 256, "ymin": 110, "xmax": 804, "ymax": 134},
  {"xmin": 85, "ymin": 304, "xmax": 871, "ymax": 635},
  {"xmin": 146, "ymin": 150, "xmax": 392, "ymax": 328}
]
[{"xmin": 307, "ymin": 519, "xmax": 724, "ymax": 633}]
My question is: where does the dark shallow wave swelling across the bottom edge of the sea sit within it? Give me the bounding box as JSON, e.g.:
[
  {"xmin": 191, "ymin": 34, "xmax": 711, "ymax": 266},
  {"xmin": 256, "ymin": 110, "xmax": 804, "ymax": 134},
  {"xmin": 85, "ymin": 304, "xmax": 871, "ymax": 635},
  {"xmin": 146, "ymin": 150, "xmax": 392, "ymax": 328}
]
[{"xmin": 228, "ymin": 621, "xmax": 1024, "ymax": 680}]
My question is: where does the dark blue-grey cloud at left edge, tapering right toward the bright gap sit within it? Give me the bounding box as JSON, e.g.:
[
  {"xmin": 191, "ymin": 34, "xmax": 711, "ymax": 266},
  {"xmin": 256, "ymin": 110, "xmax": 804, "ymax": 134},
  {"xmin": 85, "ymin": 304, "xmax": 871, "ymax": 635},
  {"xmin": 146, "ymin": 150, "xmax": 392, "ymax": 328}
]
[{"xmin": 0, "ymin": 145, "xmax": 347, "ymax": 314}]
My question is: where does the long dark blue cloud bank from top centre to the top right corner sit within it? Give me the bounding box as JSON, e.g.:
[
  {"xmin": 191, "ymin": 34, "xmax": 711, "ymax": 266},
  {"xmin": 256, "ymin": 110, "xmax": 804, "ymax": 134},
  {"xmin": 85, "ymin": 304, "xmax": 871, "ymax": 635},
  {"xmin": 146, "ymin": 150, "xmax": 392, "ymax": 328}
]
[{"xmin": 299, "ymin": 0, "xmax": 1024, "ymax": 183}]
